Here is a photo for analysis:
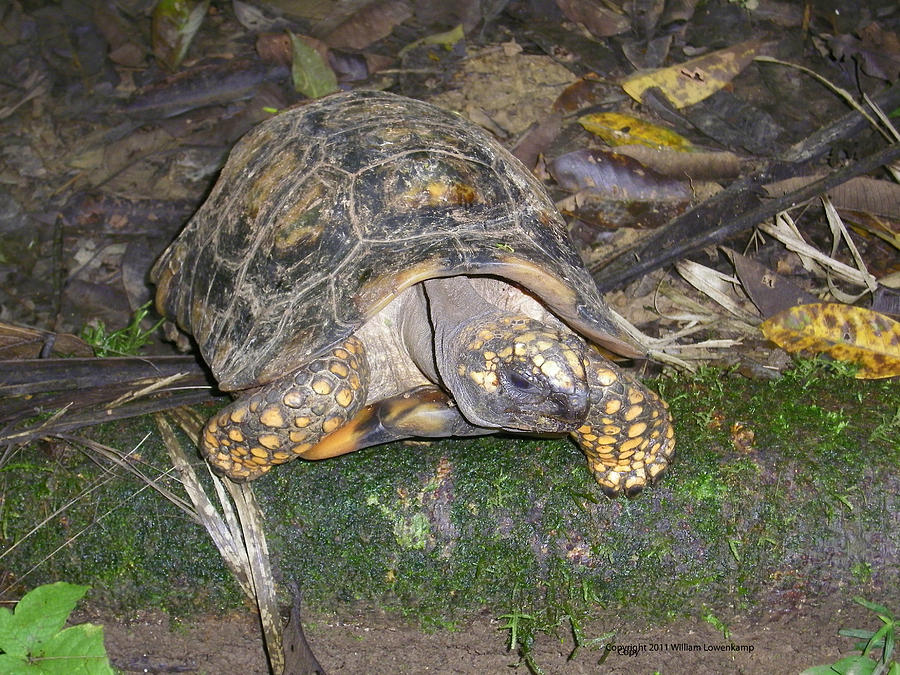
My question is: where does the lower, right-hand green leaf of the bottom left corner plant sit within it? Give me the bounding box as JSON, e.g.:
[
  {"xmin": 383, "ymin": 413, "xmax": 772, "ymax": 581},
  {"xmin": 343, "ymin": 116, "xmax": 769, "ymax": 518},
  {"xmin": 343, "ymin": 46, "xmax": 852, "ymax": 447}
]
[{"xmin": 32, "ymin": 623, "xmax": 114, "ymax": 675}]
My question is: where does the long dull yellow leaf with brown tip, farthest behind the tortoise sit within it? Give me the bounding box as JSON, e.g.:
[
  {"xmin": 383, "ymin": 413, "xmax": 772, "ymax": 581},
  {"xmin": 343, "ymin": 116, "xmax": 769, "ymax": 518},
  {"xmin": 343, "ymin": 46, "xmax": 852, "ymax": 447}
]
[{"xmin": 622, "ymin": 40, "xmax": 764, "ymax": 108}]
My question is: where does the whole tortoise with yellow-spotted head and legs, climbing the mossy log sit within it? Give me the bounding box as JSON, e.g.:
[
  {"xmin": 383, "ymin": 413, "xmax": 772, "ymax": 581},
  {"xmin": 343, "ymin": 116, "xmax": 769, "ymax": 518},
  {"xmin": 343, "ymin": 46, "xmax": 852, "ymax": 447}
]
[{"xmin": 151, "ymin": 91, "xmax": 674, "ymax": 497}]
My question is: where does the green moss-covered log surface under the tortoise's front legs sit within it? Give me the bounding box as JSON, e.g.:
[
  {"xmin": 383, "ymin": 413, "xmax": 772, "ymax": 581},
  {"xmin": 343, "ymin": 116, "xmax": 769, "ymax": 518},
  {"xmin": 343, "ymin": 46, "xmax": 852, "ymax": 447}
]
[{"xmin": 0, "ymin": 364, "xmax": 900, "ymax": 634}]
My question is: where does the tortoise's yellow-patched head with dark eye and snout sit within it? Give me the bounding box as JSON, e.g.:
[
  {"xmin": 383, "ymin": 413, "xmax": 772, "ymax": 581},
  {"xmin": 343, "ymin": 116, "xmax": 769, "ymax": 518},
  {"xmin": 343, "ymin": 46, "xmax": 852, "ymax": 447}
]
[{"xmin": 438, "ymin": 314, "xmax": 590, "ymax": 433}]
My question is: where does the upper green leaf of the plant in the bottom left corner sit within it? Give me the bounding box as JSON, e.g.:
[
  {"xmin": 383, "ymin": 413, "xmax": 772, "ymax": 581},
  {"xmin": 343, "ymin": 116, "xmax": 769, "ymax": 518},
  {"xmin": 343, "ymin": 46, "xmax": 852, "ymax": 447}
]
[{"xmin": 0, "ymin": 581, "xmax": 88, "ymax": 657}]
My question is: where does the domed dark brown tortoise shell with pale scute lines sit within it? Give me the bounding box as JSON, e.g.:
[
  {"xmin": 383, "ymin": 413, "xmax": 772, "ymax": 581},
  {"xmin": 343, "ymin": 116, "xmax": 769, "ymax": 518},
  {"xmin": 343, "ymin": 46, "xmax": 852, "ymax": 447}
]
[{"xmin": 151, "ymin": 91, "xmax": 640, "ymax": 391}]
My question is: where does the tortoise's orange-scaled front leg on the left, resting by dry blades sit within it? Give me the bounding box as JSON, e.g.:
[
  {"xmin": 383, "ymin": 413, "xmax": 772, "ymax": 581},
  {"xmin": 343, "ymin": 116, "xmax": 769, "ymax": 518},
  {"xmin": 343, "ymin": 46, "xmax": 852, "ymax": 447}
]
[{"xmin": 200, "ymin": 336, "xmax": 369, "ymax": 481}]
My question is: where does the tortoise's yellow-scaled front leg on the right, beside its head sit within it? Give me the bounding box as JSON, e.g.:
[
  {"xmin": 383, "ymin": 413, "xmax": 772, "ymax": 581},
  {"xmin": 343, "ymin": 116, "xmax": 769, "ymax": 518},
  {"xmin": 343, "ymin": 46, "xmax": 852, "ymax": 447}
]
[{"xmin": 572, "ymin": 352, "xmax": 675, "ymax": 497}]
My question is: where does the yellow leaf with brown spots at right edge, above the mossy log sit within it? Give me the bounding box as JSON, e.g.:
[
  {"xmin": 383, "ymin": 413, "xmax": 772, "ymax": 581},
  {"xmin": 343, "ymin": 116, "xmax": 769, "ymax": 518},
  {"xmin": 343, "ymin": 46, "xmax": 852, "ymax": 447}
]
[{"xmin": 761, "ymin": 303, "xmax": 900, "ymax": 379}]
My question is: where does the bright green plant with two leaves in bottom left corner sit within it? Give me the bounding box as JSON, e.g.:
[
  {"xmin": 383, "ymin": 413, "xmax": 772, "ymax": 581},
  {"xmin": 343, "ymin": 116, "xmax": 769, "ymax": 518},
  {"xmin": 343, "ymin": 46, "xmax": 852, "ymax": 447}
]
[{"xmin": 0, "ymin": 581, "xmax": 114, "ymax": 675}]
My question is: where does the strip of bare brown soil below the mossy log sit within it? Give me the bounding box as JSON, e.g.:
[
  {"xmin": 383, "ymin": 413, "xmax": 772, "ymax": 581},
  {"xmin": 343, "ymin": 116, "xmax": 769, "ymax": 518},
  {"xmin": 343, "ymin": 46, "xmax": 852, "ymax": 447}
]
[{"xmin": 89, "ymin": 599, "xmax": 877, "ymax": 675}]
